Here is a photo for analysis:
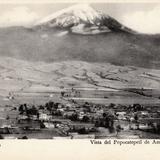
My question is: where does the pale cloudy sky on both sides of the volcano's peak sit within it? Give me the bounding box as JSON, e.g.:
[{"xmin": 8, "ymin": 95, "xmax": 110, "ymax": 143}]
[{"xmin": 0, "ymin": 3, "xmax": 160, "ymax": 33}]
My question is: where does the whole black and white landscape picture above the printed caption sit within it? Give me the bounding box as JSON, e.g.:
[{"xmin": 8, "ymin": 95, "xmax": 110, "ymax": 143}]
[{"xmin": 0, "ymin": 2, "xmax": 160, "ymax": 140}]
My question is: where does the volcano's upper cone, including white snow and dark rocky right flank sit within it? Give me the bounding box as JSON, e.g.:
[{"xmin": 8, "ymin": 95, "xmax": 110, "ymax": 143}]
[{"xmin": 35, "ymin": 4, "xmax": 133, "ymax": 34}]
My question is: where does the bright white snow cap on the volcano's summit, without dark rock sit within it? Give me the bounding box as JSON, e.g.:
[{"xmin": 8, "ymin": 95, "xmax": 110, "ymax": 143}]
[{"xmin": 37, "ymin": 4, "xmax": 101, "ymax": 26}]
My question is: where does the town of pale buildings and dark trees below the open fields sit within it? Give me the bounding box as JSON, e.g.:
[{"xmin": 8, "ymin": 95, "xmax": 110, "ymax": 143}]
[{"xmin": 0, "ymin": 98, "xmax": 160, "ymax": 139}]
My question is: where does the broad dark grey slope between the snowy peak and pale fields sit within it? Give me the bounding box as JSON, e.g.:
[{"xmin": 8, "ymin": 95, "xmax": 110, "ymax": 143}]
[{"xmin": 0, "ymin": 27, "xmax": 160, "ymax": 69}]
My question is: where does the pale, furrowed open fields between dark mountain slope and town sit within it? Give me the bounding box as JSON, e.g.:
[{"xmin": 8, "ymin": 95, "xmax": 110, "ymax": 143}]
[{"xmin": 0, "ymin": 58, "xmax": 160, "ymax": 104}]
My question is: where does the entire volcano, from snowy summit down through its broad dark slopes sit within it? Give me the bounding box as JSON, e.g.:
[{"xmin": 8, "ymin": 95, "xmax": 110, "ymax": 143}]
[{"xmin": 0, "ymin": 5, "xmax": 160, "ymax": 69}]
